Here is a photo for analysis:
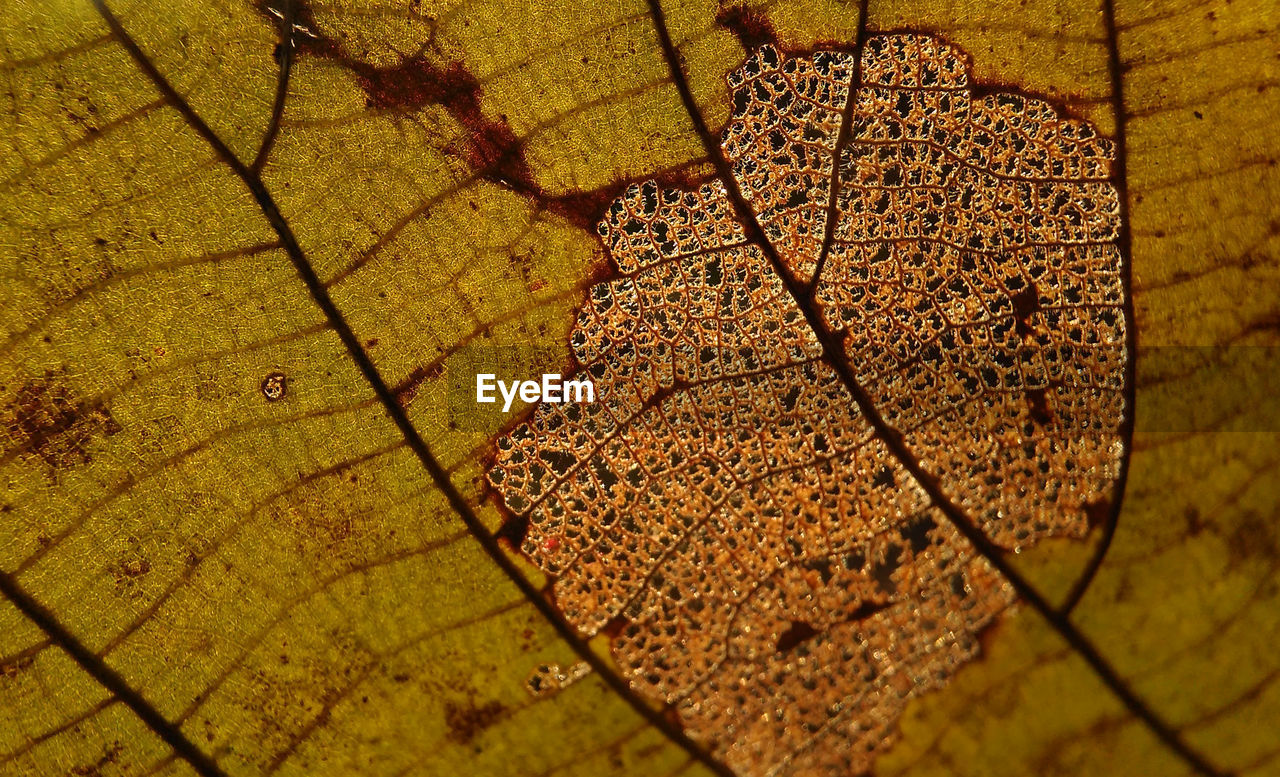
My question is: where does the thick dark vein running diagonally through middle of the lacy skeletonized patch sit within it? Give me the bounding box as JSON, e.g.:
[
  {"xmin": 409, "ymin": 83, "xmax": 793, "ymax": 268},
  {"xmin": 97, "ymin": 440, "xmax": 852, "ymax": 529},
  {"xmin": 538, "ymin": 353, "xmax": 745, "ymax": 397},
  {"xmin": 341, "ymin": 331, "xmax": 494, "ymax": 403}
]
[{"xmin": 646, "ymin": 0, "xmax": 1225, "ymax": 777}]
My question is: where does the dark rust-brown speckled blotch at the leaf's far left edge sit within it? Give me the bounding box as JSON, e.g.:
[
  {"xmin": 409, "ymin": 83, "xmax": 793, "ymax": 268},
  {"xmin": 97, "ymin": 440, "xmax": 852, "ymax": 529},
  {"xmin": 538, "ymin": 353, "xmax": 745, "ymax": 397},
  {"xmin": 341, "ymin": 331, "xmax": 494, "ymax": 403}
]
[{"xmin": 5, "ymin": 370, "xmax": 120, "ymax": 474}]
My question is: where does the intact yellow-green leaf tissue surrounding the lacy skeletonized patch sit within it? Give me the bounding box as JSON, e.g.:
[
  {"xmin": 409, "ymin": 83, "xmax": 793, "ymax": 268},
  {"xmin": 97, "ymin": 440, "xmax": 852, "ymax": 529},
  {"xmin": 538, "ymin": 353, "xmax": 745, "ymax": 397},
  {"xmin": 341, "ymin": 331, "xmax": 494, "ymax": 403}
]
[{"xmin": 0, "ymin": 0, "xmax": 1280, "ymax": 777}]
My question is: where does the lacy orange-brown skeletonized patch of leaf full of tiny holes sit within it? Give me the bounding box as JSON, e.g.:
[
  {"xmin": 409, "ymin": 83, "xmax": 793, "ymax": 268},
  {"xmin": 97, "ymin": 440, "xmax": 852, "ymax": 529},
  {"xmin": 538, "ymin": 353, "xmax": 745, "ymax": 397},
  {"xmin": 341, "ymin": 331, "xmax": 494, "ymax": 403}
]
[{"xmin": 489, "ymin": 35, "xmax": 1129, "ymax": 776}]
